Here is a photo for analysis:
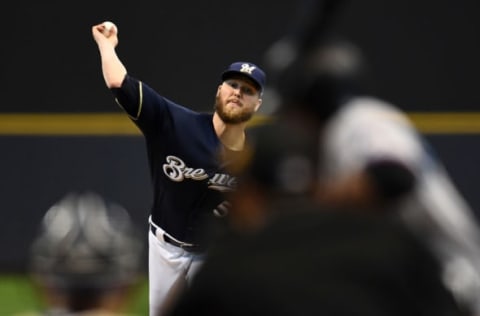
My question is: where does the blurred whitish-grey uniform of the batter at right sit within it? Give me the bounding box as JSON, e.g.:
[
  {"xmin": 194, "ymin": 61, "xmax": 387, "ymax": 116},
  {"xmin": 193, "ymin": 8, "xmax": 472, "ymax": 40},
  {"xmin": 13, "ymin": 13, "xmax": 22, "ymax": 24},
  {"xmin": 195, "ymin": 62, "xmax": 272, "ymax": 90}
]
[{"xmin": 320, "ymin": 97, "xmax": 480, "ymax": 312}]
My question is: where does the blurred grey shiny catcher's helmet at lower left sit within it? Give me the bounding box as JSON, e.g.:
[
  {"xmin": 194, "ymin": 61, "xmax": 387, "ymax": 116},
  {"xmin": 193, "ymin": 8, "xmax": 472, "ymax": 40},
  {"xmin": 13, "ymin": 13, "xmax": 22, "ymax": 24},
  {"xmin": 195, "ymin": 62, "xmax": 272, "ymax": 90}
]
[{"xmin": 30, "ymin": 193, "xmax": 143, "ymax": 292}]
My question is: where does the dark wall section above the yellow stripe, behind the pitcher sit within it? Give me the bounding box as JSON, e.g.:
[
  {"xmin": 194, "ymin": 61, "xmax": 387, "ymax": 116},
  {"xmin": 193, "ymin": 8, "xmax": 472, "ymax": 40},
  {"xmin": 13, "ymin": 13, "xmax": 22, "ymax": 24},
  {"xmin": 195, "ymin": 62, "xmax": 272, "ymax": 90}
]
[{"xmin": 0, "ymin": 0, "xmax": 480, "ymax": 112}]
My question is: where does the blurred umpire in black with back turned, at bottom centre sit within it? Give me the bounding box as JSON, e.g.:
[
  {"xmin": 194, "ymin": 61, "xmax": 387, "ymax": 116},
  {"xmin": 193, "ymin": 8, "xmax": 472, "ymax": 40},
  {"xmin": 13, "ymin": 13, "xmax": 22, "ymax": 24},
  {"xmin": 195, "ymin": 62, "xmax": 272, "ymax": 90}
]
[{"xmin": 169, "ymin": 124, "xmax": 466, "ymax": 316}]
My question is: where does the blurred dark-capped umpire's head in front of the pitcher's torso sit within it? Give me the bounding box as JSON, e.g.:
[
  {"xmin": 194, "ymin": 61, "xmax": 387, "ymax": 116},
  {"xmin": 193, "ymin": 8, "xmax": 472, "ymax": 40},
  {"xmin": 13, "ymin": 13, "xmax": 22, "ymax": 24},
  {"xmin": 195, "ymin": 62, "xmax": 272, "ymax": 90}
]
[{"xmin": 225, "ymin": 122, "xmax": 318, "ymax": 231}]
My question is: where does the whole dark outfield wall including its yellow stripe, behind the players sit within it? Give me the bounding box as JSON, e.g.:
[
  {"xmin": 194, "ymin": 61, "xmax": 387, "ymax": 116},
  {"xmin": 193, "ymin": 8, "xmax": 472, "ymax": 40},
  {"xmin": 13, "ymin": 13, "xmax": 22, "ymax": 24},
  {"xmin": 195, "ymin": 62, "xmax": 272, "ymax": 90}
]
[{"xmin": 0, "ymin": 0, "xmax": 480, "ymax": 273}]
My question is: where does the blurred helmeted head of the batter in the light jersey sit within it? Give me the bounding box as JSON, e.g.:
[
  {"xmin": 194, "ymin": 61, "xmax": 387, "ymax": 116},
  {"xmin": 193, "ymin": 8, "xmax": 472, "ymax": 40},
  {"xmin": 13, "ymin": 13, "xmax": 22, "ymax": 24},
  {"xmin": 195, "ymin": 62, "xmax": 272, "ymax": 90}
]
[{"xmin": 278, "ymin": 38, "xmax": 368, "ymax": 127}]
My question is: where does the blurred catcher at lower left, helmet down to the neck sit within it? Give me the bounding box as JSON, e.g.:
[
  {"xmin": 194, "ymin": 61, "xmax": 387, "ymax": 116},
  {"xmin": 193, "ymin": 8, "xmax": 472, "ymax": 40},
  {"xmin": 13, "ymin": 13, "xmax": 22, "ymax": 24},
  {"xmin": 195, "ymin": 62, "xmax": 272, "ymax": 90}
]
[{"xmin": 25, "ymin": 193, "xmax": 143, "ymax": 316}]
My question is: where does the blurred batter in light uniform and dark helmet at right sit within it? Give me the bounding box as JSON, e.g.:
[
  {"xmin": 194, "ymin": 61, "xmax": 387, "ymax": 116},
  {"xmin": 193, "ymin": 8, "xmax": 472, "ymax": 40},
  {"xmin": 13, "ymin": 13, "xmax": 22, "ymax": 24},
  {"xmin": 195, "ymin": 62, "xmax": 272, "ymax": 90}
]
[{"xmin": 280, "ymin": 40, "xmax": 480, "ymax": 315}]
